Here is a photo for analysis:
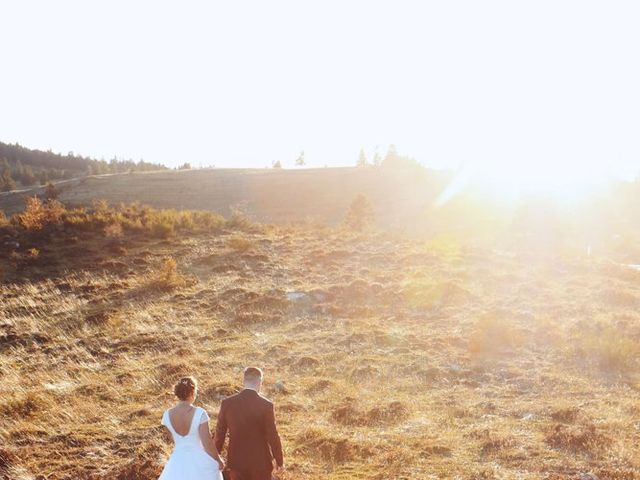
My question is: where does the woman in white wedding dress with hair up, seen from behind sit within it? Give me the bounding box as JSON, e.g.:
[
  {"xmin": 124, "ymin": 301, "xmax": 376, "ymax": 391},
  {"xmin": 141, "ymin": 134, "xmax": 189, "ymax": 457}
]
[{"xmin": 159, "ymin": 377, "xmax": 224, "ymax": 480}]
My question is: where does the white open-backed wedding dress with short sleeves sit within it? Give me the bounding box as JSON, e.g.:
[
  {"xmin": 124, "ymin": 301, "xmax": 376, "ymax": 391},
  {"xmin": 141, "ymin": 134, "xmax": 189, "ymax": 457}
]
[{"xmin": 159, "ymin": 407, "xmax": 222, "ymax": 480}]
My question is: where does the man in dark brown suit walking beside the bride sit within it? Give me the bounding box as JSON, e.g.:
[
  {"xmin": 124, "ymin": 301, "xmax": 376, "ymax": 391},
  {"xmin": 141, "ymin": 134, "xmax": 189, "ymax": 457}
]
[{"xmin": 215, "ymin": 367, "xmax": 283, "ymax": 480}]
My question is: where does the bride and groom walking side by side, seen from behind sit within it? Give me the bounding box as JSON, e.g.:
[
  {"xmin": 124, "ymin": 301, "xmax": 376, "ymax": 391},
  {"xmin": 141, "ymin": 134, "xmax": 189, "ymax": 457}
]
[{"xmin": 159, "ymin": 367, "xmax": 283, "ymax": 480}]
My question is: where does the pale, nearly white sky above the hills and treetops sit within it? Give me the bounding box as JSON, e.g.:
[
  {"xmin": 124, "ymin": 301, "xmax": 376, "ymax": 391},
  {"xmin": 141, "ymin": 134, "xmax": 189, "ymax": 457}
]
[{"xmin": 0, "ymin": 0, "xmax": 640, "ymax": 180}]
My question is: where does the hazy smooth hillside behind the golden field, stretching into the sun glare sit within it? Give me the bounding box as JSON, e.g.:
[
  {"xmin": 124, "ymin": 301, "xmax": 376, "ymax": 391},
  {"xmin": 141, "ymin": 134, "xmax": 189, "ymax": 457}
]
[{"xmin": 0, "ymin": 166, "xmax": 640, "ymax": 256}]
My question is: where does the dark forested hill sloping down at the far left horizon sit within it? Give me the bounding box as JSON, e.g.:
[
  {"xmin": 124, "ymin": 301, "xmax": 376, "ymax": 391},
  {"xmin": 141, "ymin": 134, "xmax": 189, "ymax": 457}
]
[{"xmin": 0, "ymin": 142, "xmax": 166, "ymax": 191}]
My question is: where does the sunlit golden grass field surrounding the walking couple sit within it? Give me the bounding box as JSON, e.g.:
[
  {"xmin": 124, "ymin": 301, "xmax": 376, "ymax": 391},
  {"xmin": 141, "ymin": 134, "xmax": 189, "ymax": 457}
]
[{"xmin": 0, "ymin": 187, "xmax": 640, "ymax": 480}]
